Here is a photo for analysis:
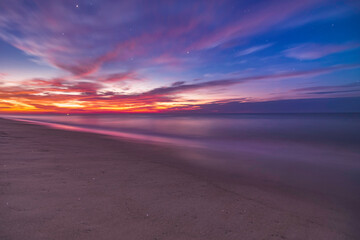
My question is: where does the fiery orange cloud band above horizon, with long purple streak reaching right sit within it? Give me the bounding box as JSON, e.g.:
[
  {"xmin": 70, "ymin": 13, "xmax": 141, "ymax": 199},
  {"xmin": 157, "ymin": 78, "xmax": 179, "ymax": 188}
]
[{"xmin": 0, "ymin": 62, "xmax": 360, "ymax": 111}]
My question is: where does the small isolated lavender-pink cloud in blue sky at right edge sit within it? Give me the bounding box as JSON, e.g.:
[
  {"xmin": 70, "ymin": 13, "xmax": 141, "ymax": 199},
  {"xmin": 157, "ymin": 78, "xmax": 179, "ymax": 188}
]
[{"xmin": 284, "ymin": 43, "xmax": 360, "ymax": 60}]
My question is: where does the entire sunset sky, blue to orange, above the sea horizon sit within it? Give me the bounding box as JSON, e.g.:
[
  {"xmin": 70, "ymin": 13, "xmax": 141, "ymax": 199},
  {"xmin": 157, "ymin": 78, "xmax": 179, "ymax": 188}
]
[{"xmin": 0, "ymin": 0, "xmax": 360, "ymax": 113}]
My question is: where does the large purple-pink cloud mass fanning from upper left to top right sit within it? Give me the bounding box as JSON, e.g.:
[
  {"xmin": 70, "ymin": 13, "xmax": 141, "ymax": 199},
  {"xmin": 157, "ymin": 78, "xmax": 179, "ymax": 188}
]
[{"xmin": 0, "ymin": 0, "xmax": 338, "ymax": 78}]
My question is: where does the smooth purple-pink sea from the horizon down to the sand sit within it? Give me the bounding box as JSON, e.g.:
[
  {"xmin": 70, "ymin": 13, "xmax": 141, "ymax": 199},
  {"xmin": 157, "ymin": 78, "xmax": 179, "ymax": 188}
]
[{"xmin": 2, "ymin": 114, "xmax": 360, "ymax": 205}]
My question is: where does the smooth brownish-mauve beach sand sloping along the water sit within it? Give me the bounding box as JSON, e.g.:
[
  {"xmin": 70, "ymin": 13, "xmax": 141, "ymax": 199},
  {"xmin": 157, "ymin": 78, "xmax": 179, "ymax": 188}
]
[{"xmin": 0, "ymin": 119, "xmax": 360, "ymax": 240}]
